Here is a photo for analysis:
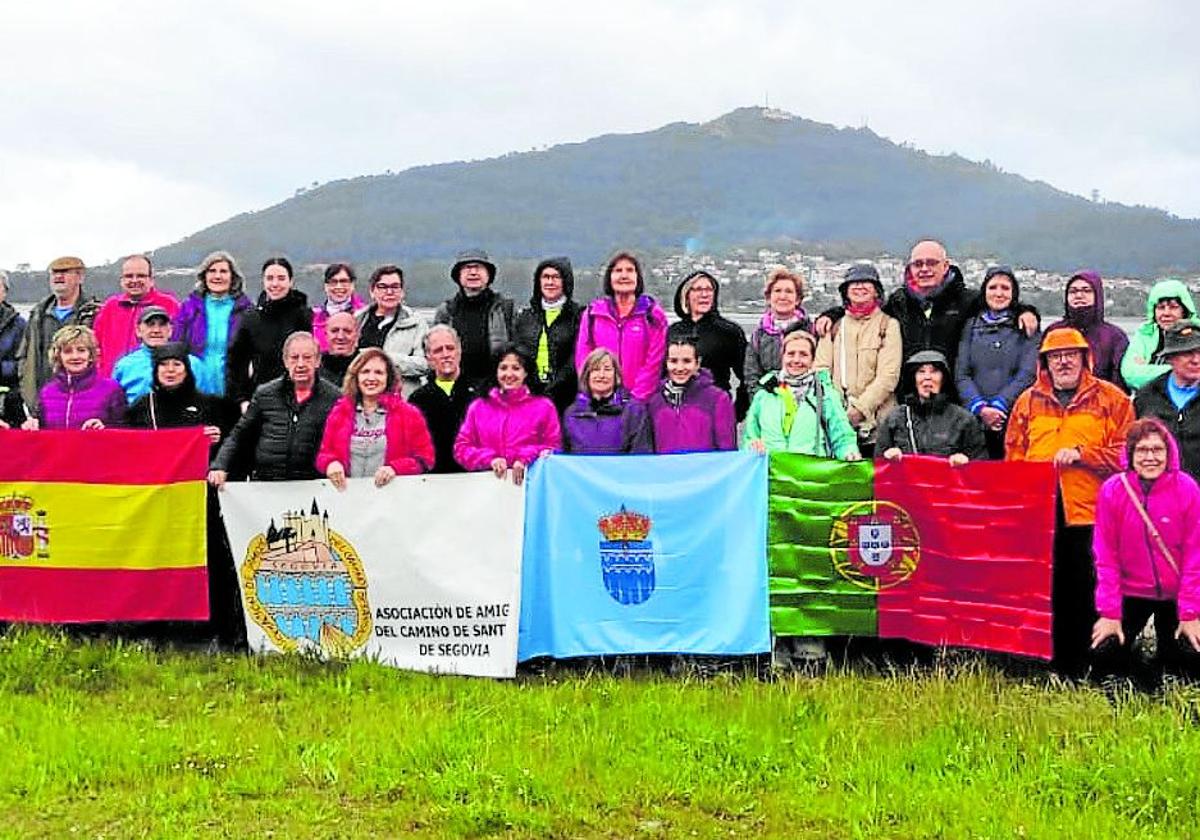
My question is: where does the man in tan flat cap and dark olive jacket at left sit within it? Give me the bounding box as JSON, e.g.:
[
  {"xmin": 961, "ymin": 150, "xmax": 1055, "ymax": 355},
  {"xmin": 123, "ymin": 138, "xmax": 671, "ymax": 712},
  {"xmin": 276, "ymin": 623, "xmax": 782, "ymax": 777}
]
[{"xmin": 17, "ymin": 257, "xmax": 100, "ymax": 414}]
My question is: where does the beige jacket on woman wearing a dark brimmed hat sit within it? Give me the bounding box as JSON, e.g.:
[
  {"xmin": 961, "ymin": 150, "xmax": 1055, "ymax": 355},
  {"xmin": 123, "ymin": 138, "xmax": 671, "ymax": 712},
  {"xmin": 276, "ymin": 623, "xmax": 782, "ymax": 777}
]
[{"xmin": 816, "ymin": 302, "xmax": 904, "ymax": 440}]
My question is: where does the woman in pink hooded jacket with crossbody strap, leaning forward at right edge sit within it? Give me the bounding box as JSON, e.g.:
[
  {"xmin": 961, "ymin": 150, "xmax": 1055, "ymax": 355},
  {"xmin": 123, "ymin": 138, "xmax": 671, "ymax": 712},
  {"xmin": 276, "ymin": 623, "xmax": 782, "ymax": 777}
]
[{"xmin": 1092, "ymin": 418, "xmax": 1200, "ymax": 674}]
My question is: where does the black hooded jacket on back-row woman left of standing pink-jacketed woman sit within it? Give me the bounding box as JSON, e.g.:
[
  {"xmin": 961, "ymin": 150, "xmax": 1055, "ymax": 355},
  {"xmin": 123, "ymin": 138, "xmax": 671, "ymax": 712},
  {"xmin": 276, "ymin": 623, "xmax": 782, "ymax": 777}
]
[{"xmin": 514, "ymin": 257, "xmax": 583, "ymax": 412}]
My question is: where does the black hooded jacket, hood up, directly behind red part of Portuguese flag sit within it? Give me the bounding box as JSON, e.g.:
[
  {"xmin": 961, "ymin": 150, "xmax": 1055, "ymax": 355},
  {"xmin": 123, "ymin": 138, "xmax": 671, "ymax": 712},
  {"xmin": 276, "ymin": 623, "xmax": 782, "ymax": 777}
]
[{"xmin": 876, "ymin": 350, "xmax": 988, "ymax": 461}]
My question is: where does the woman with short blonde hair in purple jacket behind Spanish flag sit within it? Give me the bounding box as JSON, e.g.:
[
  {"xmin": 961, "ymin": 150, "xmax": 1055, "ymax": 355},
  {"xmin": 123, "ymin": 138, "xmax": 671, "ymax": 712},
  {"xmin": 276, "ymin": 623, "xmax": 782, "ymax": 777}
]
[{"xmin": 34, "ymin": 325, "xmax": 126, "ymax": 428}]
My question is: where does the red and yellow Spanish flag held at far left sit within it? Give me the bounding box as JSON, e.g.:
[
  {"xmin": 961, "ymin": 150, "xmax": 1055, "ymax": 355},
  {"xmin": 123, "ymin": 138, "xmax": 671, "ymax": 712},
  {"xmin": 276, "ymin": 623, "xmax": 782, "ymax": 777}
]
[{"xmin": 0, "ymin": 428, "xmax": 209, "ymax": 623}]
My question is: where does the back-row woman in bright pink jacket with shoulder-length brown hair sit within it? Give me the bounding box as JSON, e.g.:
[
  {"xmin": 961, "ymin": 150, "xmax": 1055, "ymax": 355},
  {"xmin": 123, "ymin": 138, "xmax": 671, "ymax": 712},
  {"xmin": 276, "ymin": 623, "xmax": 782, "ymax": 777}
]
[{"xmin": 575, "ymin": 251, "xmax": 667, "ymax": 400}]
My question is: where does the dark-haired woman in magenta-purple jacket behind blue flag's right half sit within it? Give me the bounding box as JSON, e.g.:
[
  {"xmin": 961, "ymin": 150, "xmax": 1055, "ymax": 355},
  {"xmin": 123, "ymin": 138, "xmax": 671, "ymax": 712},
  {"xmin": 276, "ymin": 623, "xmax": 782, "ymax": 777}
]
[{"xmin": 647, "ymin": 337, "xmax": 738, "ymax": 452}]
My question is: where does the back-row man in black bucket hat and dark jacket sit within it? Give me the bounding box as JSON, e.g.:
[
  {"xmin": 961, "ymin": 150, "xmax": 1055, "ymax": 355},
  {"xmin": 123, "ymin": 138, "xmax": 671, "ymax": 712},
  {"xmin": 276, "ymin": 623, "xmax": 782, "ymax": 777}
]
[{"xmin": 433, "ymin": 248, "xmax": 514, "ymax": 385}]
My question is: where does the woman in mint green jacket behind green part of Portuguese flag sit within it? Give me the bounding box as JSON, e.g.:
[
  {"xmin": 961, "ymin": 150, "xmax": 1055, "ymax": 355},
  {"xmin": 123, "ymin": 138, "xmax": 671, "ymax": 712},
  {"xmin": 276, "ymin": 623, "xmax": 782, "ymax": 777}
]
[{"xmin": 742, "ymin": 329, "xmax": 862, "ymax": 461}]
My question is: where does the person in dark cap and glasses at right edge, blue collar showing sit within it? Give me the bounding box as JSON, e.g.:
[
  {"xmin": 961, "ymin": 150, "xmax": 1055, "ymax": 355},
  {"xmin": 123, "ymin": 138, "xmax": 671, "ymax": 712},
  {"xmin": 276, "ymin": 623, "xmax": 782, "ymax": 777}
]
[{"xmin": 1133, "ymin": 319, "xmax": 1200, "ymax": 480}]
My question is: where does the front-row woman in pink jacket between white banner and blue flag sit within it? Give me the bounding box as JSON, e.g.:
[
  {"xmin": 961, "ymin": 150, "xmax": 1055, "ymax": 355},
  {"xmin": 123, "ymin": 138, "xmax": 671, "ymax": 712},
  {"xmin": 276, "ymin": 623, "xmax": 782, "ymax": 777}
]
[{"xmin": 454, "ymin": 344, "xmax": 562, "ymax": 485}]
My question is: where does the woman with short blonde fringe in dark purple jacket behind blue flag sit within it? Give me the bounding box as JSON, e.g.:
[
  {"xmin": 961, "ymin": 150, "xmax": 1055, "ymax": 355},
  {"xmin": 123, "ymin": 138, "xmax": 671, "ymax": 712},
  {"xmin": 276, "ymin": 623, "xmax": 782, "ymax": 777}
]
[{"xmin": 563, "ymin": 347, "xmax": 654, "ymax": 455}]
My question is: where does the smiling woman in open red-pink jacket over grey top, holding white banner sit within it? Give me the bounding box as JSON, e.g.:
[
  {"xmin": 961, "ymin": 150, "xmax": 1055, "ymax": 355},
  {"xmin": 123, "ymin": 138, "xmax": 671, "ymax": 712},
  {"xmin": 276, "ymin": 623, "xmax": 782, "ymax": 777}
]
[{"xmin": 317, "ymin": 347, "xmax": 433, "ymax": 490}]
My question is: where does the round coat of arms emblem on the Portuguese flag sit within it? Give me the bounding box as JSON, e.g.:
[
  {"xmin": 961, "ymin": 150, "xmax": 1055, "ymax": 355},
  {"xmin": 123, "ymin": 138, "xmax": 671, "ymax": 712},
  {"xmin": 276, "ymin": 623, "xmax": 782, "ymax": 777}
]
[{"xmin": 829, "ymin": 500, "xmax": 920, "ymax": 592}]
